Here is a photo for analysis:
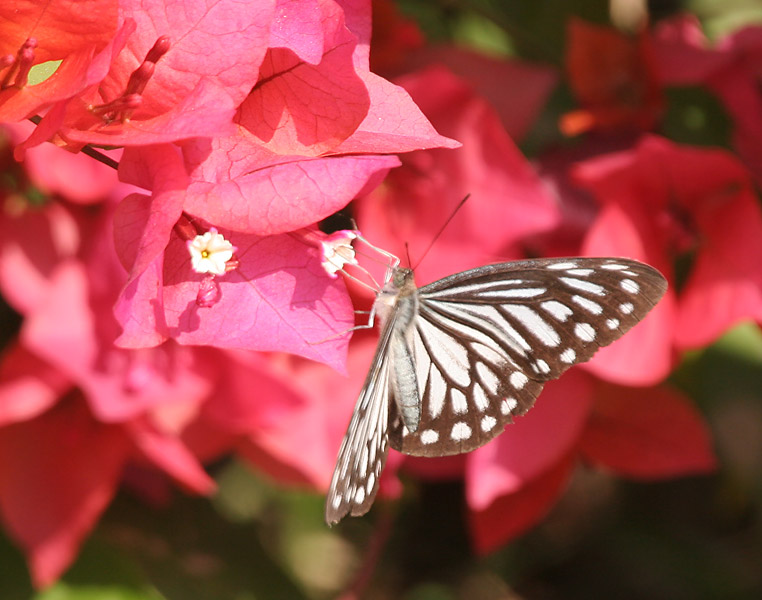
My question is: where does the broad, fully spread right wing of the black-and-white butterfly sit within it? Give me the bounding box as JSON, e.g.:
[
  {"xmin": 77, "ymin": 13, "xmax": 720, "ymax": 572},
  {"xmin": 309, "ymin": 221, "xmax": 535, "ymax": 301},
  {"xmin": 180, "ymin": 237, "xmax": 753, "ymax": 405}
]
[{"xmin": 388, "ymin": 258, "xmax": 667, "ymax": 456}]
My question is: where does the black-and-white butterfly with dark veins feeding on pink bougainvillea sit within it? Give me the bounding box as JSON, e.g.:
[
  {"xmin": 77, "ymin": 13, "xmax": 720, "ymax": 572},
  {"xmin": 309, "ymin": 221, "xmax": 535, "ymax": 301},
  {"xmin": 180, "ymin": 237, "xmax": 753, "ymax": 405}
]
[{"xmin": 325, "ymin": 246, "xmax": 667, "ymax": 524}]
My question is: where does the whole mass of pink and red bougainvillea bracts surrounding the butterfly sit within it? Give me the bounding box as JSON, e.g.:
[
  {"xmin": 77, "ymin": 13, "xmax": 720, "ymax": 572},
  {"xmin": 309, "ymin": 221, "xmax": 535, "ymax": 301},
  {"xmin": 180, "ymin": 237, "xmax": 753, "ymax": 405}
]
[{"xmin": 0, "ymin": 0, "xmax": 762, "ymax": 586}]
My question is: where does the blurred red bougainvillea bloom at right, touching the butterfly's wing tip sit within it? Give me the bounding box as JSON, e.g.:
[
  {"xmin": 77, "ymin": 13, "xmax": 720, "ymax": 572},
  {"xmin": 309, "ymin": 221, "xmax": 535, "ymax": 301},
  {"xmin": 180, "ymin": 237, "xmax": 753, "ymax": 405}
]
[{"xmin": 575, "ymin": 137, "xmax": 762, "ymax": 370}]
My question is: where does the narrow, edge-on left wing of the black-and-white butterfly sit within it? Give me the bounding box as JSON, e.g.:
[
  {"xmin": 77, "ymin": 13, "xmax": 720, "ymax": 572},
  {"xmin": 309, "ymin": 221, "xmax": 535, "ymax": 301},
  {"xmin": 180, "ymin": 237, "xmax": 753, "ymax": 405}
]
[{"xmin": 325, "ymin": 306, "xmax": 397, "ymax": 524}]
